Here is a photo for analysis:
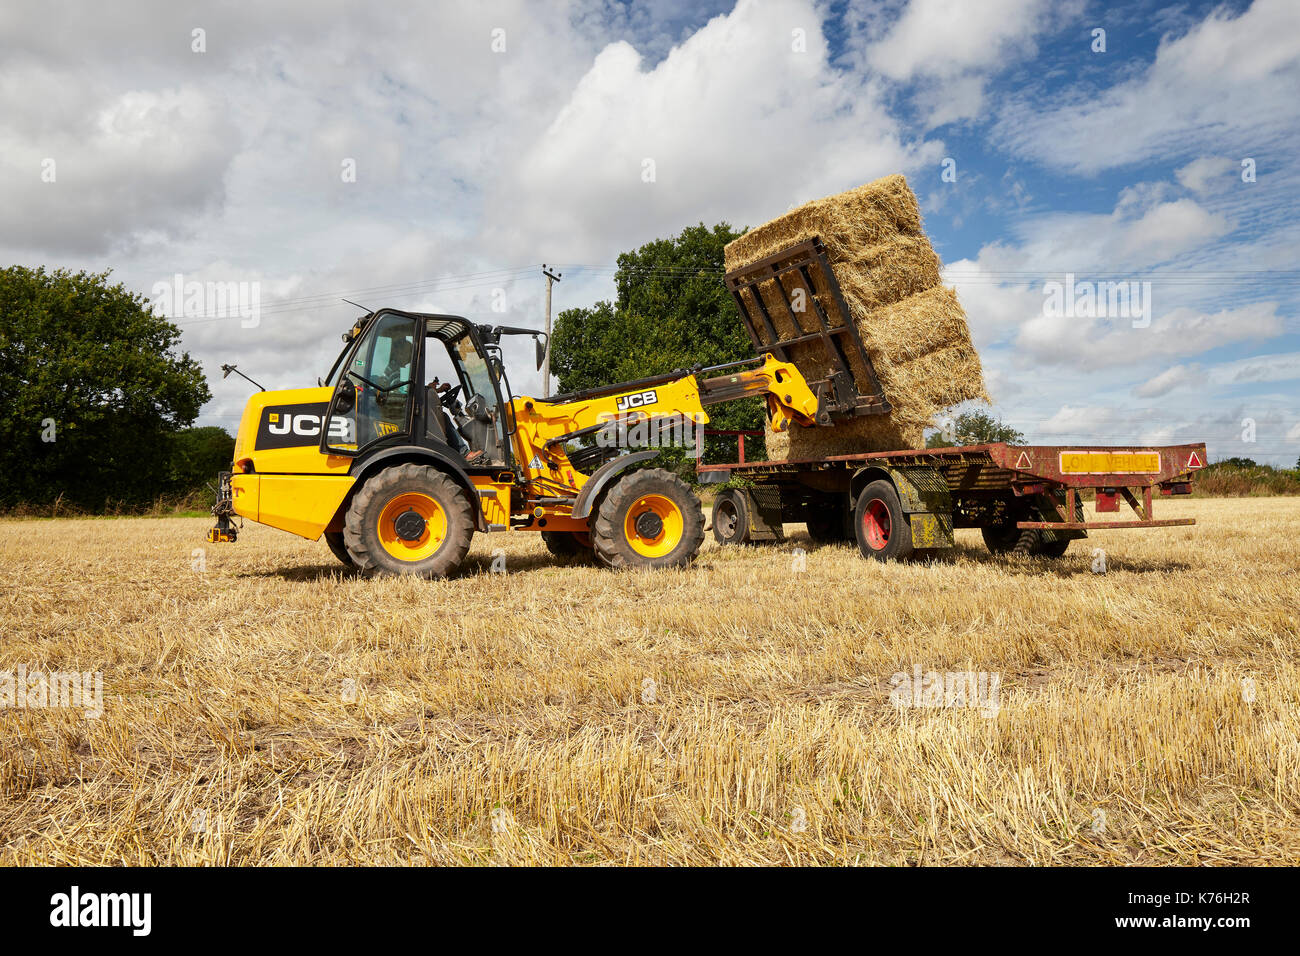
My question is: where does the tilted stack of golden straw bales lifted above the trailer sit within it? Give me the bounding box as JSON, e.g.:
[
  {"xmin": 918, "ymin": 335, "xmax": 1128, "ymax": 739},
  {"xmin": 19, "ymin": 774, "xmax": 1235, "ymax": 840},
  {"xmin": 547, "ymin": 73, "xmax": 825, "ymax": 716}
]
[{"xmin": 725, "ymin": 176, "xmax": 988, "ymax": 459}]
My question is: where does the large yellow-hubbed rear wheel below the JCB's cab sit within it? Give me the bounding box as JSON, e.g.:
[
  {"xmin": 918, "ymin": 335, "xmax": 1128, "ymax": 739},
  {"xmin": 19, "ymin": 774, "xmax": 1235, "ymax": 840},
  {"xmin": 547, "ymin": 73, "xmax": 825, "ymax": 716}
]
[{"xmin": 343, "ymin": 463, "xmax": 475, "ymax": 578}]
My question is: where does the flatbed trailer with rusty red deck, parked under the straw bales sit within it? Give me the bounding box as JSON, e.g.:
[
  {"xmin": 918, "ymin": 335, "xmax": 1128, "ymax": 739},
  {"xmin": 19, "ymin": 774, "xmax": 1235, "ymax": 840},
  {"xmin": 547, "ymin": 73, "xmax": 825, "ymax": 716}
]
[{"xmin": 697, "ymin": 442, "xmax": 1205, "ymax": 561}]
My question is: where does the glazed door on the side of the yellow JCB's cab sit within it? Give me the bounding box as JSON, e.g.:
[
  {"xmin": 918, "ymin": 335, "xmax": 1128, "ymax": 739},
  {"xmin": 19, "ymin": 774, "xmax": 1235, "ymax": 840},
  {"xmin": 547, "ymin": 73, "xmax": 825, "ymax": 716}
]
[{"xmin": 321, "ymin": 312, "xmax": 423, "ymax": 458}]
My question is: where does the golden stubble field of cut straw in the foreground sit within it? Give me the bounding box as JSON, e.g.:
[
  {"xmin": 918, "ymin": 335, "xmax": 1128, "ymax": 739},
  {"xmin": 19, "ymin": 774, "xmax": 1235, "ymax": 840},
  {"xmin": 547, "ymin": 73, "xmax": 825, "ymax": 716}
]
[{"xmin": 0, "ymin": 498, "xmax": 1300, "ymax": 865}]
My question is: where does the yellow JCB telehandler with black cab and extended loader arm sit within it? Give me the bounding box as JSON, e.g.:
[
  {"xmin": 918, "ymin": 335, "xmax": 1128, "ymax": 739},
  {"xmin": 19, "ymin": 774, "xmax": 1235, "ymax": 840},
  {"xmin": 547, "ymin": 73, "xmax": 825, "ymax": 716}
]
[{"xmin": 208, "ymin": 290, "xmax": 889, "ymax": 578}]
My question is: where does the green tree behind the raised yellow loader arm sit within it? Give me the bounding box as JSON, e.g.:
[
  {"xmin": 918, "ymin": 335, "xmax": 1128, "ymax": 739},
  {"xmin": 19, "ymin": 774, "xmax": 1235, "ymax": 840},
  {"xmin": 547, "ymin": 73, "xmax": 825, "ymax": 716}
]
[{"xmin": 551, "ymin": 222, "xmax": 766, "ymax": 458}]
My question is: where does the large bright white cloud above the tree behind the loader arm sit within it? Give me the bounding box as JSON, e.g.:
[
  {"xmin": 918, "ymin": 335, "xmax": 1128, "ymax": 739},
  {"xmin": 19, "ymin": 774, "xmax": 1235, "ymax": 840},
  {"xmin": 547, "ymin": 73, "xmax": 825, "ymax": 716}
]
[{"xmin": 490, "ymin": 0, "xmax": 941, "ymax": 261}]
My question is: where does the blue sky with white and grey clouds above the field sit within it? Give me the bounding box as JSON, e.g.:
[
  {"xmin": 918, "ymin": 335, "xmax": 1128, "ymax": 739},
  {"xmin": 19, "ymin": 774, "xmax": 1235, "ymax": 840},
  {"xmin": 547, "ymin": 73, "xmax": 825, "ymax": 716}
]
[{"xmin": 0, "ymin": 0, "xmax": 1300, "ymax": 464}]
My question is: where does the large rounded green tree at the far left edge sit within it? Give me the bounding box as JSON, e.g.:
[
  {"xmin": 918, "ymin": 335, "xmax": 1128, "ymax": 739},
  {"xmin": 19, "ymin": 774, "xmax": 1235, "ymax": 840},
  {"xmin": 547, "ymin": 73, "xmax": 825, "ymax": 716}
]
[{"xmin": 0, "ymin": 265, "xmax": 211, "ymax": 509}]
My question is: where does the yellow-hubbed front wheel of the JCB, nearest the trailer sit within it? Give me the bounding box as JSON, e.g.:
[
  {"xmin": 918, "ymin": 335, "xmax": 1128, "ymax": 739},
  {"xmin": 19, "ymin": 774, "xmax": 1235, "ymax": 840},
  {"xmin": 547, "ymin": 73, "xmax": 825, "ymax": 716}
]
[{"xmin": 592, "ymin": 468, "xmax": 705, "ymax": 568}]
